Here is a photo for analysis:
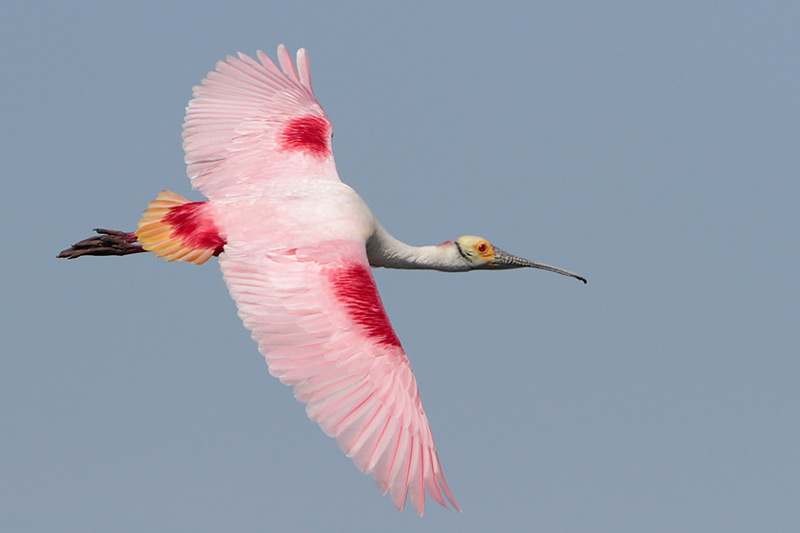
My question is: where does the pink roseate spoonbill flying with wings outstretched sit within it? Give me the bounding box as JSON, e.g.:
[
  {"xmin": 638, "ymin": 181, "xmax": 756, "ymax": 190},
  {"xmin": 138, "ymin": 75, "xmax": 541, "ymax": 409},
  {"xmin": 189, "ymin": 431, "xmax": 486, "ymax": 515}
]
[{"xmin": 54, "ymin": 45, "xmax": 586, "ymax": 516}]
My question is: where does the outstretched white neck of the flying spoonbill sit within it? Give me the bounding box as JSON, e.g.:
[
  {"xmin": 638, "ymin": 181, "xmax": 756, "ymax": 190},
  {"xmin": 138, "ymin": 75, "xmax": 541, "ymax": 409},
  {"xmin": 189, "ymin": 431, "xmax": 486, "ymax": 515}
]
[{"xmin": 367, "ymin": 224, "xmax": 469, "ymax": 272}]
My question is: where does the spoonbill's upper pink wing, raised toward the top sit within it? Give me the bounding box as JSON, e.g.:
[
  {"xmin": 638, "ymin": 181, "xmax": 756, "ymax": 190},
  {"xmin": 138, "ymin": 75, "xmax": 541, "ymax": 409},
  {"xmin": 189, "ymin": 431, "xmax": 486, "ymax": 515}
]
[{"xmin": 183, "ymin": 45, "xmax": 339, "ymax": 199}]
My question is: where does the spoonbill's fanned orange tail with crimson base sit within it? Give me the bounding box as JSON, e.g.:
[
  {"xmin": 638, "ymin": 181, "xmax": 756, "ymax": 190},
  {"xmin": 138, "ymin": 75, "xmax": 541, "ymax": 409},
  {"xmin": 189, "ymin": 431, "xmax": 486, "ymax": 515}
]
[{"xmin": 136, "ymin": 190, "xmax": 225, "ymax": 265}]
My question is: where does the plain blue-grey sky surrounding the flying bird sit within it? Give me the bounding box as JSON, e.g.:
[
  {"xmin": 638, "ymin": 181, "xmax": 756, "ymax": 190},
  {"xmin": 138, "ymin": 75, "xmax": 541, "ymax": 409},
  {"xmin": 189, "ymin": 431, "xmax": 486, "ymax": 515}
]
[{"xmin": 0, "ymin": 0, "xmax": 800, "ymax": 532}]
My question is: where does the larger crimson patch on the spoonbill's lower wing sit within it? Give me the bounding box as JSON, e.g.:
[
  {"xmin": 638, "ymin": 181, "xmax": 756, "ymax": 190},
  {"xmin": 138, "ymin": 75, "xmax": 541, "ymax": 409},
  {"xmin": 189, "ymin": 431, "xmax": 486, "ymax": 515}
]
[{"xmin": 330, "ymin": 265, "xmax": 401, "ymax": 347}]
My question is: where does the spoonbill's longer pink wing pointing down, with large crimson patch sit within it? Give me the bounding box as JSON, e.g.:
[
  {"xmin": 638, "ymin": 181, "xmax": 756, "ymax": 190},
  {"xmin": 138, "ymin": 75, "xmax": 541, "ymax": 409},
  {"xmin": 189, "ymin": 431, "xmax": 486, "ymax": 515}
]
[{"xmin": 220, "ymin": 241, "xmax": 458, "ymax": 515}]
